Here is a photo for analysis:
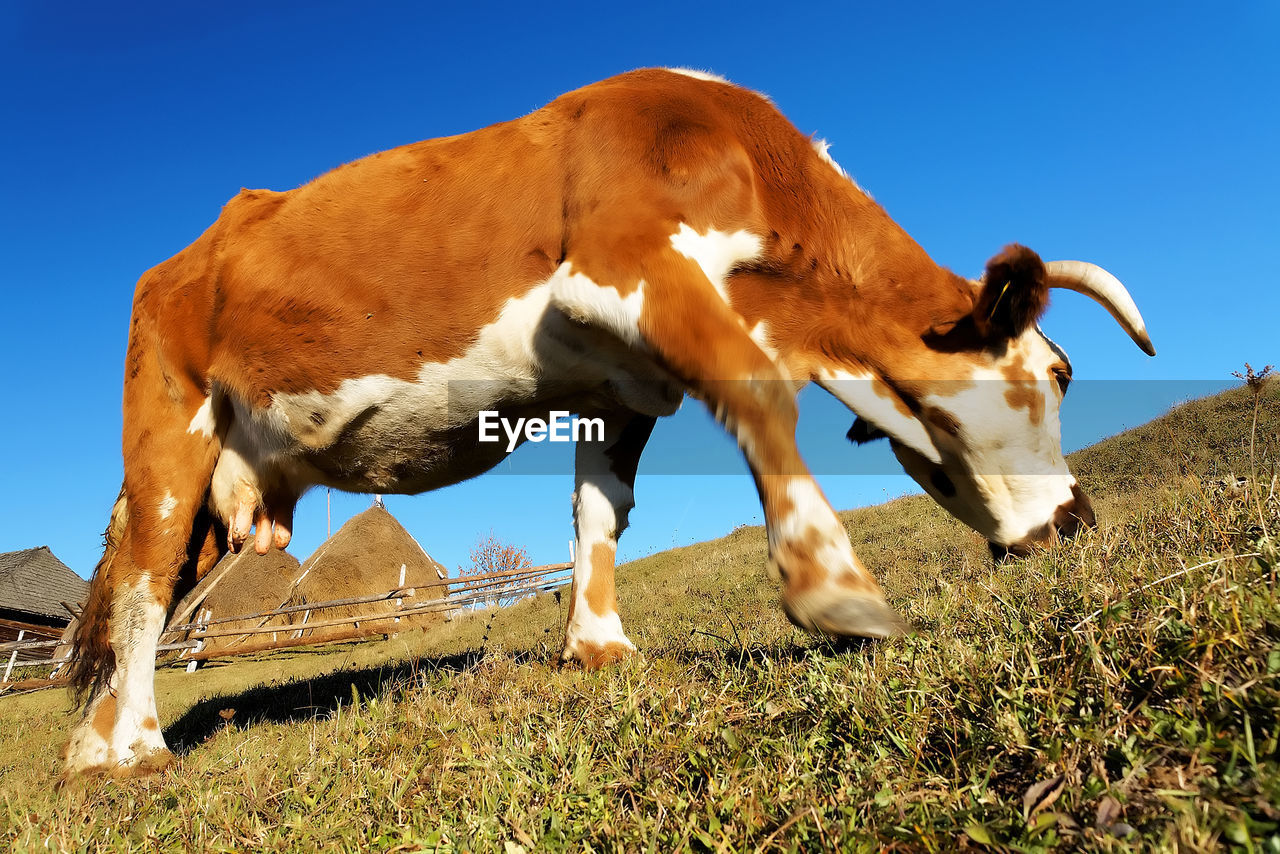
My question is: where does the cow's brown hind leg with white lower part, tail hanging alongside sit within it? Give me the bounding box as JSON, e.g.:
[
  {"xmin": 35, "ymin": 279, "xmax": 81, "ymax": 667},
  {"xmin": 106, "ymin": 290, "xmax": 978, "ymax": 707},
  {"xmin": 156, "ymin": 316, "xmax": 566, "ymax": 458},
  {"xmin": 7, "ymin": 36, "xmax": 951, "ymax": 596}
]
[{"xmin": 64, "ymin": 356, "xmax": 218, "ymax": 776}]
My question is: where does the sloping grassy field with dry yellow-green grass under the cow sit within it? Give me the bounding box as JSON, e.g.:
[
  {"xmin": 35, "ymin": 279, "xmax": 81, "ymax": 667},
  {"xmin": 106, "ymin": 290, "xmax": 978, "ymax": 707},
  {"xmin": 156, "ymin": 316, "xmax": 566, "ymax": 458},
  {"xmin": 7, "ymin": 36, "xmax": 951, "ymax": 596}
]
[{"xmin": 0, "ymin": 389, "xmax": 1280, "ymax": 853}]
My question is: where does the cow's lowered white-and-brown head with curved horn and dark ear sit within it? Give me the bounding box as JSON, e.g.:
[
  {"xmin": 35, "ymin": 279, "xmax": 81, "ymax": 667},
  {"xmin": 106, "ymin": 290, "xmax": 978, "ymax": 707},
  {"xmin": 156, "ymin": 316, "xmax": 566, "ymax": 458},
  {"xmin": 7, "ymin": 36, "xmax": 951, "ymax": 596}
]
[{"xmin": 817, "ymin": 246, "xmax": 1155, "ymax": 558}]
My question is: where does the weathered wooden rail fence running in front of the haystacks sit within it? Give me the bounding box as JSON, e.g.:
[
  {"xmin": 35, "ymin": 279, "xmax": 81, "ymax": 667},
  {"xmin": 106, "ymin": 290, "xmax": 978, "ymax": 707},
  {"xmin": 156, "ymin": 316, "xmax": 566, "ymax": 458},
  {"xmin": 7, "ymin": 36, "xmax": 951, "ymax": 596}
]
[{"xmin": 0, "ymin": 563, "xmax": 573, "ymax": 694}]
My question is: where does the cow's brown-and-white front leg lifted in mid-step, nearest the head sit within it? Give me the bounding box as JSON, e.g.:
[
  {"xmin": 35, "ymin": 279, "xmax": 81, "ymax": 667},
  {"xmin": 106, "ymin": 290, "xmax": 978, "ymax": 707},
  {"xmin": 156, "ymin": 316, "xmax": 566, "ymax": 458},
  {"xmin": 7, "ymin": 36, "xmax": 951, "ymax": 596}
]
[{"xmin": 640, "ymin": 255, "xmax": 904, "ymax": 638}]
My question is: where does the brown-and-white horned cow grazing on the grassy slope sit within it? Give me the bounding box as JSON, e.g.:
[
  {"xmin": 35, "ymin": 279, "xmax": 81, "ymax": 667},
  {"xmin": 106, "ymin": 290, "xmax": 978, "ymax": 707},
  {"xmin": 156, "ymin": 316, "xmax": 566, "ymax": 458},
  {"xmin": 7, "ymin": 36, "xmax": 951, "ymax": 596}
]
[{"xmin": 64, "ymin": 69, "xmax": 1155, "ymax": 776}]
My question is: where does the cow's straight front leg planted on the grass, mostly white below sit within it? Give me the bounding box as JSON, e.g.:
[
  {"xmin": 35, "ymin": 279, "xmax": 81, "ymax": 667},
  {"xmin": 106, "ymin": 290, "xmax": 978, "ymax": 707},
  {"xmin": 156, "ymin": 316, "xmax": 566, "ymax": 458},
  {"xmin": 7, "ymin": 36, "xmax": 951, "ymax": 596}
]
[{"xmin": 561, "ymin": 412, "xmax": 654, "ymax": 670}]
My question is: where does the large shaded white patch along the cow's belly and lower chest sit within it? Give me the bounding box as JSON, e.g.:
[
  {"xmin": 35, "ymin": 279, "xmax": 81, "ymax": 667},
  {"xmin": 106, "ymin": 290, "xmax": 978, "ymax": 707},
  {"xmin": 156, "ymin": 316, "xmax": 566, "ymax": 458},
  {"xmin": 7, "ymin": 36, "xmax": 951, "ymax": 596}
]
[{"xmin": 222, "ymin": 273, "xmax": 684, "ymax": 501}]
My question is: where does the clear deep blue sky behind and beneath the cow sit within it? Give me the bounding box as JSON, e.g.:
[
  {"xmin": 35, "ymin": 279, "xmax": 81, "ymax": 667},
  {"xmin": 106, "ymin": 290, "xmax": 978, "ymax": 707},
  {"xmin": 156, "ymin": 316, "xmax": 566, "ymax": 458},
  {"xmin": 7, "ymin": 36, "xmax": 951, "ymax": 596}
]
[{"xmin": 0, "ymin": 0, "xmax": 1280, "ymax": 575}]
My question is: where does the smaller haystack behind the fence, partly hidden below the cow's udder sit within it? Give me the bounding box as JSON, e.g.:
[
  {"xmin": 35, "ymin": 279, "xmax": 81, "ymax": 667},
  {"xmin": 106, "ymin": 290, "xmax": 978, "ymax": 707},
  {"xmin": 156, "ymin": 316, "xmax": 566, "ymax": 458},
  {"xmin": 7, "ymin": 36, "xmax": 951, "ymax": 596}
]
[{"xmin": 161, "ymin": 548, "xmax": 302, "ymax": 652}]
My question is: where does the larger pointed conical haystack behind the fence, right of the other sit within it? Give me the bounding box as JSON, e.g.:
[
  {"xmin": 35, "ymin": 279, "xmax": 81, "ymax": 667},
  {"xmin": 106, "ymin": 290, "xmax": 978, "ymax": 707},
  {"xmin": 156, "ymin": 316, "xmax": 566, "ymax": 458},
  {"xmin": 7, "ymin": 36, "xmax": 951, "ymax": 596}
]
[{"xmin": 289, "ymin": 503, "xmax": 448, "ymax": 639}]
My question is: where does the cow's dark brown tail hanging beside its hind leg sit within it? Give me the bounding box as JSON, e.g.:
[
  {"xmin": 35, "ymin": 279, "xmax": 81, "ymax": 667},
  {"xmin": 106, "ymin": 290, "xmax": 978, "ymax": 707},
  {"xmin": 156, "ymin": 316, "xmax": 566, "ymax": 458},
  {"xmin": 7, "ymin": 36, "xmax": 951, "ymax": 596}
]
[{"xmin": 68, "ymin": 487, "xmax": 129, "ymax": 703}]
